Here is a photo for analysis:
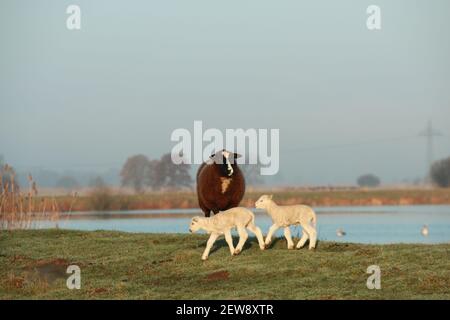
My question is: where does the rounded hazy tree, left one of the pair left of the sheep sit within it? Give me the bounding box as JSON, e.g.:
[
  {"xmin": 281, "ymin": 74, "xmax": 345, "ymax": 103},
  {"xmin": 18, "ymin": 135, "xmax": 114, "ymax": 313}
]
[{"xmin": 120, "ymin": 154, "xmax": 150, "ymax": 193}]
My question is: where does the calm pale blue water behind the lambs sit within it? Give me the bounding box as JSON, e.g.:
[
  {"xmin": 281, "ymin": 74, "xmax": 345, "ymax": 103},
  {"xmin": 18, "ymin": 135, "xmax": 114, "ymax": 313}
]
[{"xmin": 39, "ymin": 205, "xmax": 450, "ymax": 243}]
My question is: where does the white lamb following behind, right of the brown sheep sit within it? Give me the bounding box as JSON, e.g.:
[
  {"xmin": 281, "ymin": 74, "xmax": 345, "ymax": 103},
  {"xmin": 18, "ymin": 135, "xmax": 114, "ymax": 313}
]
[{"xmin": 255, "ymin": 195, "xmax": 317, "ymax": 249}]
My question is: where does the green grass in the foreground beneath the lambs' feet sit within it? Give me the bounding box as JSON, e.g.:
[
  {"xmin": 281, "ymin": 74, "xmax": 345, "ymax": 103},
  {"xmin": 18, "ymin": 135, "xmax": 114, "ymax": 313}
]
[{"xmin": 0, "ymin": 230, "xmax": 450, "ymax": 299}]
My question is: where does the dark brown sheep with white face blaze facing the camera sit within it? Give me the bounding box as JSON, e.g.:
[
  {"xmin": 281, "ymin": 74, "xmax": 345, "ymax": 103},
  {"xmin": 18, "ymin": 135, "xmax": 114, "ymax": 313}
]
[{"xmin": 197, "ymin": 150, "xmax": 245, "ymax": 217}]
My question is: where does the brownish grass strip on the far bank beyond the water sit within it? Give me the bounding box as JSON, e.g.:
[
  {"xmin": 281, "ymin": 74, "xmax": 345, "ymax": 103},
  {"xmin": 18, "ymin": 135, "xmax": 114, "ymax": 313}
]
[{"xmin": 43, "ymin": 188, "xmax": 450, "ymax": 211}]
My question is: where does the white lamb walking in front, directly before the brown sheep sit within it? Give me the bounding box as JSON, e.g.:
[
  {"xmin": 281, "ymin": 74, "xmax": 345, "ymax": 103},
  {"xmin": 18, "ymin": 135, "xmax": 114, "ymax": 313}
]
[{"xmin": 189, "ymin": 207, "xmax": 265, "ymax": 260}]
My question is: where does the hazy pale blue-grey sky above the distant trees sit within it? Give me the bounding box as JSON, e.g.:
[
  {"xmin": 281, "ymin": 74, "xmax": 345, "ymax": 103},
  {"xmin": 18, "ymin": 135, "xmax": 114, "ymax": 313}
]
[{"xmin": 0, "ymin": 0, "xmax": 450, "ymax": 184}]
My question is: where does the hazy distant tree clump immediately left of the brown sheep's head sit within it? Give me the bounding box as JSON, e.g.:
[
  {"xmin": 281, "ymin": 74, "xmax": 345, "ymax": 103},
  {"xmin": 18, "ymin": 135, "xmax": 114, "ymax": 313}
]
[{"xmin": 147, "ymin": 153, "xmax": 192, "ymax": 189}]
